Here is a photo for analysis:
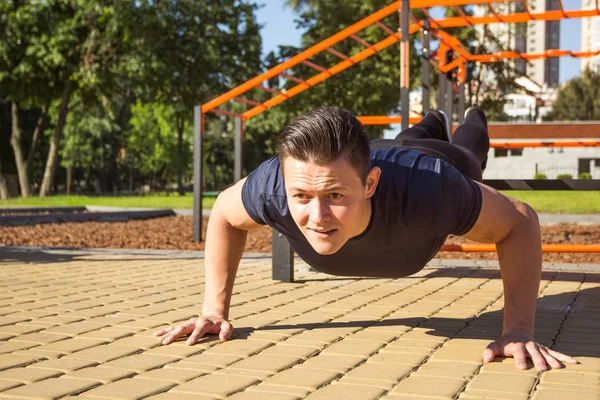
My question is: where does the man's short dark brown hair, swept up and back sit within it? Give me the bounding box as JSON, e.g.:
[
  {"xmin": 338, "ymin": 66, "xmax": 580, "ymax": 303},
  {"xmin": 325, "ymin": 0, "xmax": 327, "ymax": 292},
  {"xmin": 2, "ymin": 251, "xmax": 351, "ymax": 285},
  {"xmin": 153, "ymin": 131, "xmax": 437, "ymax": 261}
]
[{"xmin": 275, "ymin": 107, "xmax": 371, "ymax": 184}]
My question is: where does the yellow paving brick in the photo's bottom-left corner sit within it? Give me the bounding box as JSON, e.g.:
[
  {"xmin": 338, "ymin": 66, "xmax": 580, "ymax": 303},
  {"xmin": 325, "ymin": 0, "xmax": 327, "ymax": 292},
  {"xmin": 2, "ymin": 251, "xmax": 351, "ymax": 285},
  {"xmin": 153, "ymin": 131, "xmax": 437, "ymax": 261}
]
[{"xmin": 2, "ymin": 377, "xmax": 100, "ymax": 399}]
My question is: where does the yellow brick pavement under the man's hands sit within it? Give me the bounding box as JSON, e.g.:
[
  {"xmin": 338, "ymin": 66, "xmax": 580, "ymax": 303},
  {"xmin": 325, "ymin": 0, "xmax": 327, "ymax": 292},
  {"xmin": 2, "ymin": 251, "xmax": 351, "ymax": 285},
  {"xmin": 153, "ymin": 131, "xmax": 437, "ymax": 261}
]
[{"xmin": 0, "ymin": 254, "xmax": 600, "ymax": 400}]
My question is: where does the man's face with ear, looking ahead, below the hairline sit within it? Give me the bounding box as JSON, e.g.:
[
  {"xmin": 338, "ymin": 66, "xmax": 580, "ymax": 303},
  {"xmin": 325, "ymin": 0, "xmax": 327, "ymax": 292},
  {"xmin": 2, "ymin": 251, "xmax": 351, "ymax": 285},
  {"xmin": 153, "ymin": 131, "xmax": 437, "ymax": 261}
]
[{"xmin": 283, "ymin": 157, "xmax": 380, "ymax": 255}]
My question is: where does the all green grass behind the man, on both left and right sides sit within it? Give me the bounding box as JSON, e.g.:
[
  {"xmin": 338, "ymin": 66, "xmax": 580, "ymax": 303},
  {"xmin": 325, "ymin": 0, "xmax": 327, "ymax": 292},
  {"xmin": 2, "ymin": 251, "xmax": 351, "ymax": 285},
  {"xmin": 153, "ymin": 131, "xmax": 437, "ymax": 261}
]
[{"xmin": 0, "ymin": 190, "xmax": 600, "ymax": 214}]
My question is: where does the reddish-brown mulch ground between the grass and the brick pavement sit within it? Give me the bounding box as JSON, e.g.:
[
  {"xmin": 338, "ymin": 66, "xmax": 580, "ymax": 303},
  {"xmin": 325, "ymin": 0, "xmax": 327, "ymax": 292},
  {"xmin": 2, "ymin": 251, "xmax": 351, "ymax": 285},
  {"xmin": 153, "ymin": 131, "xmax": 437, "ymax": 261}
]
[{"xmin": 0, "ymin": 216, "xmax": 600, "ymax": 264}]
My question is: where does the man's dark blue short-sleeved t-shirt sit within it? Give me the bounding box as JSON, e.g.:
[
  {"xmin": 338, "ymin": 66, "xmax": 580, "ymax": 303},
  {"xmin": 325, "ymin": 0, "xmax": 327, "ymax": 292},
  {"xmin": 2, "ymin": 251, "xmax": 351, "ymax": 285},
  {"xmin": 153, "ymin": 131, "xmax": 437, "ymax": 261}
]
[{"xmin": 242, "ymin": 147, "xmax": 481, "ymax": 277}]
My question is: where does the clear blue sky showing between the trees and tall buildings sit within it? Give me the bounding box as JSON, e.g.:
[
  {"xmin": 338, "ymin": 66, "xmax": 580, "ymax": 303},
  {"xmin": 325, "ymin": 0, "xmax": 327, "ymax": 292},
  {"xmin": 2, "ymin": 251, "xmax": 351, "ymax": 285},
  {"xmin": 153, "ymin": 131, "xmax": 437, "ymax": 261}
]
[{"xmin": 257, "ymin": 0, "xmax": 581, "ymax": 83}]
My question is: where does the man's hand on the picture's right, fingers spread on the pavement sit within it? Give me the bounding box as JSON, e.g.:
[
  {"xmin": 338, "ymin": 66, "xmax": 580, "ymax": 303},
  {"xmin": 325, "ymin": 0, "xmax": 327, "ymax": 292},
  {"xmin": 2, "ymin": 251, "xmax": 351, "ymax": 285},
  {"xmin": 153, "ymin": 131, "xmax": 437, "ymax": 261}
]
[{"xmin": 482, "ymin": 333, "xmax": 579, "ymax": 371}]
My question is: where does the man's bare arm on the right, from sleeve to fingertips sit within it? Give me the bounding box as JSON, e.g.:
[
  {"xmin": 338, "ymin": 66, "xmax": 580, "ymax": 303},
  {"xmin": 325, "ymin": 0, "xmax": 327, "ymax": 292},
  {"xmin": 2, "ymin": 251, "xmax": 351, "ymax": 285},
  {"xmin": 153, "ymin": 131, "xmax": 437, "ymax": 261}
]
[{"xmin": 465, "ymin": 184, "xmax": 576, "ymax": 370}]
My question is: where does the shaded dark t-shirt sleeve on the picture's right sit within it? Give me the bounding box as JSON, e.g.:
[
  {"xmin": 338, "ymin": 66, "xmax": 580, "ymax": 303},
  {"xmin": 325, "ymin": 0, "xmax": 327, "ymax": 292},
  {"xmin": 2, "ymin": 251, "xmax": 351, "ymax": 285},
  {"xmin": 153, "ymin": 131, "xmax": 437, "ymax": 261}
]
[{"xmin": 437, "ymin": 161, "xmax": 482, "ymax": 236}]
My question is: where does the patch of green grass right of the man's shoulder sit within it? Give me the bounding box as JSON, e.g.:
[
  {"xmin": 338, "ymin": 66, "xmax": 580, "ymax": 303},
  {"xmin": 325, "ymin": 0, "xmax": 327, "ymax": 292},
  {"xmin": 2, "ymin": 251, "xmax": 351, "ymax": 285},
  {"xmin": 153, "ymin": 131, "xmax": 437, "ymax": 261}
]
[{"xmin": 502, "ymin": 190, "xmax": 600, "ymax": 214}]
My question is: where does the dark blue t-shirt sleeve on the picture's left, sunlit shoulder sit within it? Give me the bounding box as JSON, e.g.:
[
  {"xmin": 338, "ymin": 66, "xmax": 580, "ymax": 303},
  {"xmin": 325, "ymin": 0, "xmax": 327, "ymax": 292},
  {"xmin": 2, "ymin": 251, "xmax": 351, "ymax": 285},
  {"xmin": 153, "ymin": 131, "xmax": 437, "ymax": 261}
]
[{"xmin": 242, "ymin": 157, "xmax": 279, "ymax": 225}]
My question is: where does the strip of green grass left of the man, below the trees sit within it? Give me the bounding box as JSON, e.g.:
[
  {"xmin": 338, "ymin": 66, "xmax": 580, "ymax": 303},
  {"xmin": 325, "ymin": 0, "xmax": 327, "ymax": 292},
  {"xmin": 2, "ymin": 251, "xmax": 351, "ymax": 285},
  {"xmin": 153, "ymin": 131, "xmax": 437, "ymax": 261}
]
[{"xmin": 0, "ymin": 193, "xmax": 216, "ymax": 209}]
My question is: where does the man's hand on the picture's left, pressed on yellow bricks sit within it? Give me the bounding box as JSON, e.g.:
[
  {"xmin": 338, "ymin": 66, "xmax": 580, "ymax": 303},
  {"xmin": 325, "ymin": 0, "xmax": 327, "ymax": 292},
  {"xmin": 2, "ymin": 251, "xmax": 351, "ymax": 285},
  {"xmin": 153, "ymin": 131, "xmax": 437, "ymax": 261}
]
[{"xmin": 154, "ymin": 314, "xmax": 233, "ymax": 346}]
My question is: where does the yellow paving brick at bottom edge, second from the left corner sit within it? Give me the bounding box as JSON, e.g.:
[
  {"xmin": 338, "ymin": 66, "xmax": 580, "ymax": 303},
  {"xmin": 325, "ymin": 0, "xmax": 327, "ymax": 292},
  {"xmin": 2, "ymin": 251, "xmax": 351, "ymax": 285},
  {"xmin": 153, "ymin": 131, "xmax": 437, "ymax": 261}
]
[{"xmin": 77, "ymin": 379, "xmax": 175, "ymax": 400}]
